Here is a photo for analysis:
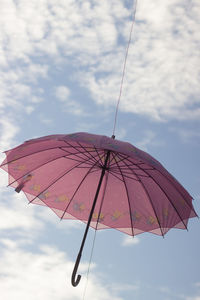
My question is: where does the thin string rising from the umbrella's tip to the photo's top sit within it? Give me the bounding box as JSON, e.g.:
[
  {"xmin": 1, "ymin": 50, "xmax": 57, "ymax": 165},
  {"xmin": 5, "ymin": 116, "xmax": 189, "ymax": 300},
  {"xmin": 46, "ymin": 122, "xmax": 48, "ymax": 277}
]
[{"xmin": 112, "ymin": 0, "xmax": 137, "ymax": 136}]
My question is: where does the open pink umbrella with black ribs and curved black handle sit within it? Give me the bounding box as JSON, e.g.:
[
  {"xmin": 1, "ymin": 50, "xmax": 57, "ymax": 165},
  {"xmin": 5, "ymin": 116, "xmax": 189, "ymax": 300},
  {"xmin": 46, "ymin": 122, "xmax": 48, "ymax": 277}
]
[{"xmin": 1, "ymin": 133, "xmax": 197, "ymax": 286}]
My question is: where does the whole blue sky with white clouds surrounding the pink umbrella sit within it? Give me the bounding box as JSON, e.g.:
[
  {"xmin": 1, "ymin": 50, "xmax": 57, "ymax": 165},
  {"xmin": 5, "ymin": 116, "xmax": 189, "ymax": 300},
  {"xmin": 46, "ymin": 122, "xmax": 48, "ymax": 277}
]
[{"xmin": 0, "ymin": 0, "xmax": 200, "ymax": 300}]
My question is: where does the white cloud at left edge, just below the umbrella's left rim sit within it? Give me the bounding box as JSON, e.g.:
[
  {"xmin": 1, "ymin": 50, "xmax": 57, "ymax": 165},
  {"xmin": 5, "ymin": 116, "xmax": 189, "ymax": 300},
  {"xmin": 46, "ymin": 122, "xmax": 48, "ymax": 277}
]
[{"xmin": 0, "ymin": 183, "xmax": 83, "ymax": 237}]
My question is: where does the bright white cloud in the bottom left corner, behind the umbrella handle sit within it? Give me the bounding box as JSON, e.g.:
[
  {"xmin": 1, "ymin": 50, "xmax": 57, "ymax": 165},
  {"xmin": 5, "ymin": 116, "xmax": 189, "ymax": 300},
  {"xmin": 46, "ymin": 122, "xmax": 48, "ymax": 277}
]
[{"xmin": 0, "ymin": 240, "xmax": 121, "ymax": 300}]
